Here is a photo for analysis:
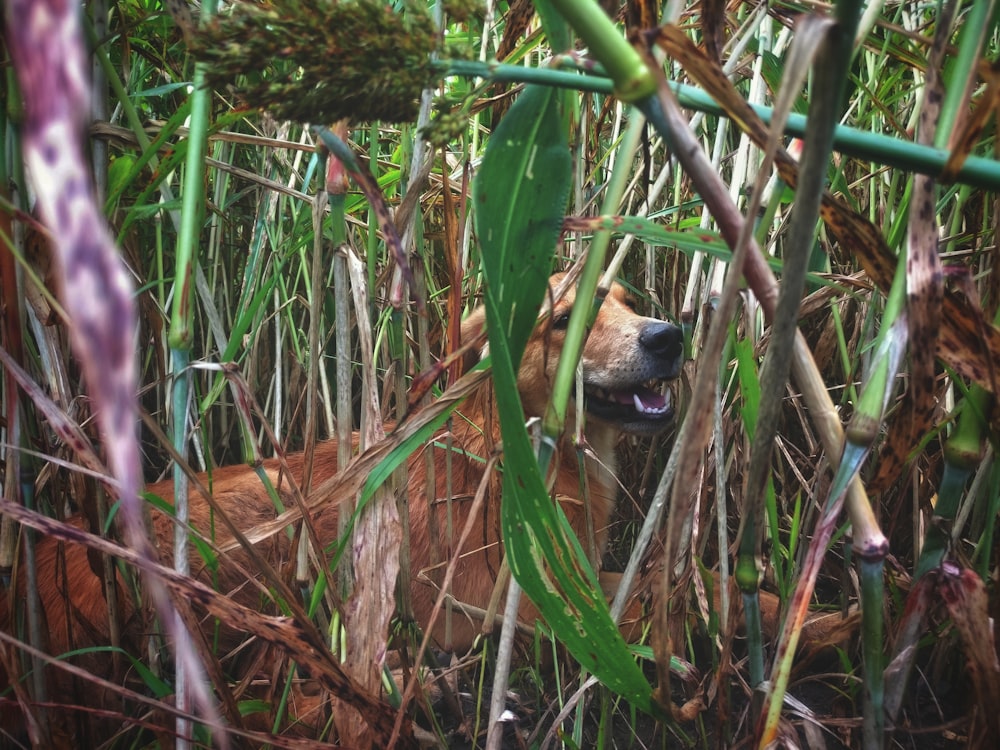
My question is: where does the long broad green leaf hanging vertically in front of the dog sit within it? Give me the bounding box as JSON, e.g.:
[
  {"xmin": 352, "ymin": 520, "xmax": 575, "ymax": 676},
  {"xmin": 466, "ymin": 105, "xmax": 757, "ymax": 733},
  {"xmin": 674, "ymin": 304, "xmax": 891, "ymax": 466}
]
[{"xmin": 473, "ymin": 87, "xmax": 652, "ymax": 711}]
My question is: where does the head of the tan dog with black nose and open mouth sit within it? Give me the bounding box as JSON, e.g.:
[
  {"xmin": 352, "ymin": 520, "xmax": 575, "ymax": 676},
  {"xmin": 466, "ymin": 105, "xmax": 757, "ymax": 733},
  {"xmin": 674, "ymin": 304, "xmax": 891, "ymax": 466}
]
[{"xmin": 462, "ymin": 274, "xmax": 684, "ymax": 435}]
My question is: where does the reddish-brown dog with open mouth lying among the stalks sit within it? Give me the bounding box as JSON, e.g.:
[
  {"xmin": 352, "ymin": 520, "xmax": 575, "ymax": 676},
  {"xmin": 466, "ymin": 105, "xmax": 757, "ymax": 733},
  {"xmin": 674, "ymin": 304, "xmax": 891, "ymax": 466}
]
[{"xmin": 4, "ymin": 275, "xmax": 682, "ymax": 736}]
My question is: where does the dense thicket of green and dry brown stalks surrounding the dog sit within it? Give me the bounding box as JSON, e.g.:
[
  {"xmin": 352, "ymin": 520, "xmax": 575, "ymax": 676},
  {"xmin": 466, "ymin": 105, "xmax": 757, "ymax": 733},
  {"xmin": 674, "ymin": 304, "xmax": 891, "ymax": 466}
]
[{"xmin": 0, "ymin": 0, "xmax": 1000, "ymax": 748}]
